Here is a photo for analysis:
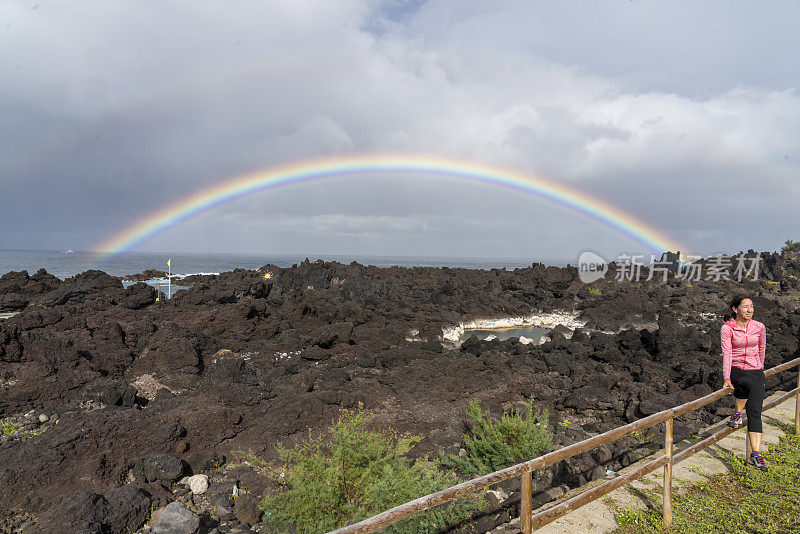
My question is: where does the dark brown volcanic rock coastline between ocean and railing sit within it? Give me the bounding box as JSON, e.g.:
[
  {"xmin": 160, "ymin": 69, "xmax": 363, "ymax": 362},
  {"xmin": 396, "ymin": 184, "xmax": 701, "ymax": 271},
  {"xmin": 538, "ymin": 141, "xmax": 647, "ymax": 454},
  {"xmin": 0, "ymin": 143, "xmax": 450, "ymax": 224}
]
[{"xmin": 0, "ymin": 251, "xmax": 800, "ymax": 533}]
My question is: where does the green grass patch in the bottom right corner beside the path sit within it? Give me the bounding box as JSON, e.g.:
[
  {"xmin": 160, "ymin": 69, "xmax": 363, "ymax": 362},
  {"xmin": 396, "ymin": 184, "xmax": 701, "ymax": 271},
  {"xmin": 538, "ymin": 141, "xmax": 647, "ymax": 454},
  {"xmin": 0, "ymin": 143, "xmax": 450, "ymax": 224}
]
[{"xmin": 614, "ymin": 429, "xmax": 800, "ymax": 534}]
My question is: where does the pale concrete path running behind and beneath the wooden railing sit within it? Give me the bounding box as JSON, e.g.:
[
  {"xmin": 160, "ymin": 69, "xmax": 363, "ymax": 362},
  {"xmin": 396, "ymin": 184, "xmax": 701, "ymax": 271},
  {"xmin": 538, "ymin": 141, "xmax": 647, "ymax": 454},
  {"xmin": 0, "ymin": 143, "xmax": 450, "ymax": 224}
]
[{"xmin": 491, "ymin": 392, "xmax": 795, "ymax": 534}]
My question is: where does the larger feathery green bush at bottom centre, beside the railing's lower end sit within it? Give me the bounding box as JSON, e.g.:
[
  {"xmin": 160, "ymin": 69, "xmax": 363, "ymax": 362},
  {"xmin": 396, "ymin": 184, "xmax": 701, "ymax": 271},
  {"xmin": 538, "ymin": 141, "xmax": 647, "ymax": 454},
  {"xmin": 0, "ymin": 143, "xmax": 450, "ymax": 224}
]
[{"xmin": 261, "ymin": 407, "xmax": 482, "ymax": 533}]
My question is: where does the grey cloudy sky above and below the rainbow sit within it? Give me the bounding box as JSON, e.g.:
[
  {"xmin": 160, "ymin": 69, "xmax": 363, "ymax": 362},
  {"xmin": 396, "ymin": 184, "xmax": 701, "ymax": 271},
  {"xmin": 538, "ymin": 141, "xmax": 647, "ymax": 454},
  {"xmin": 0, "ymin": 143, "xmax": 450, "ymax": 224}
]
[{"xmin": 0, "ymin": 0, "xmax": 800, "ymax": 258}]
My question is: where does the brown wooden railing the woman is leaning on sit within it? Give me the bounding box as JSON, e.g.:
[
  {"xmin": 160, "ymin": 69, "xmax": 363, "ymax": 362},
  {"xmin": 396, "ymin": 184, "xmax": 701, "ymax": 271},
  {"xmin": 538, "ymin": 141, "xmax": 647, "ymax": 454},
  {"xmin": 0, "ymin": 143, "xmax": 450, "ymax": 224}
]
[{"xmin": 330, "ymin": 358, "xmax": 800, "ymax": 534}]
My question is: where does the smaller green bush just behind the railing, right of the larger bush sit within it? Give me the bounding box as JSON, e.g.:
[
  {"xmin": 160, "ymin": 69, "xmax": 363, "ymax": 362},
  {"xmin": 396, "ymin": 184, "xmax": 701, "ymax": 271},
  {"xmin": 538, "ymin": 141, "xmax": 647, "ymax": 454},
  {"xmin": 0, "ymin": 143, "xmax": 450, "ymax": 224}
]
[{"xmin": 439, "ymin": 398, "xmax": 553, "ymax": 477}]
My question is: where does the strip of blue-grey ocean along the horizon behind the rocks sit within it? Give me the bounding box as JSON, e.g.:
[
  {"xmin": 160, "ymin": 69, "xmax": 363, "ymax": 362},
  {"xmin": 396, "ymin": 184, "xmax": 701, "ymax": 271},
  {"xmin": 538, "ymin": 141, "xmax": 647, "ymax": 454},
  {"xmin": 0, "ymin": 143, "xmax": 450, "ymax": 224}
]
[{"xmin": 0, "ymin": 249, "xmax": 576, "ymax": 280}]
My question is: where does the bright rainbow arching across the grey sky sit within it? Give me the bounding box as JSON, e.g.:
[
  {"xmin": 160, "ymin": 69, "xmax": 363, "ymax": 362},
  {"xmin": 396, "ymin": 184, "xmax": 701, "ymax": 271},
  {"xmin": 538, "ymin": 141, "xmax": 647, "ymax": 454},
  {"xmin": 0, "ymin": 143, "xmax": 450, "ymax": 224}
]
[{"xmin": 94, "ymin": 154, "xmax": 688, "ymax": 259}]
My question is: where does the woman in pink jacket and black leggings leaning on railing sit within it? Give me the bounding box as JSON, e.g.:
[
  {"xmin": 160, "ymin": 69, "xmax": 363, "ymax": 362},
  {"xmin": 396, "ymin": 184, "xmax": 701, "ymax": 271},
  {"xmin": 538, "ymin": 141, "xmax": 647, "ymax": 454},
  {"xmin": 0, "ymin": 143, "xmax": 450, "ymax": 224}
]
[{"xmin": 720, "ymin": 296, "xmax": 767, "ymax": 471}]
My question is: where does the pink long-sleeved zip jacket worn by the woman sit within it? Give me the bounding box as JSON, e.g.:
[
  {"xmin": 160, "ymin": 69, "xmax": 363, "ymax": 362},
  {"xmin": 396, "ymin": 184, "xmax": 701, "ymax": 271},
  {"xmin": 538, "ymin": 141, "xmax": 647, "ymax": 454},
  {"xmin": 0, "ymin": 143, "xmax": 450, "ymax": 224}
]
[{"xmin": 720, "ymin": 318, "xmax": 767, "ymax": 380}]
